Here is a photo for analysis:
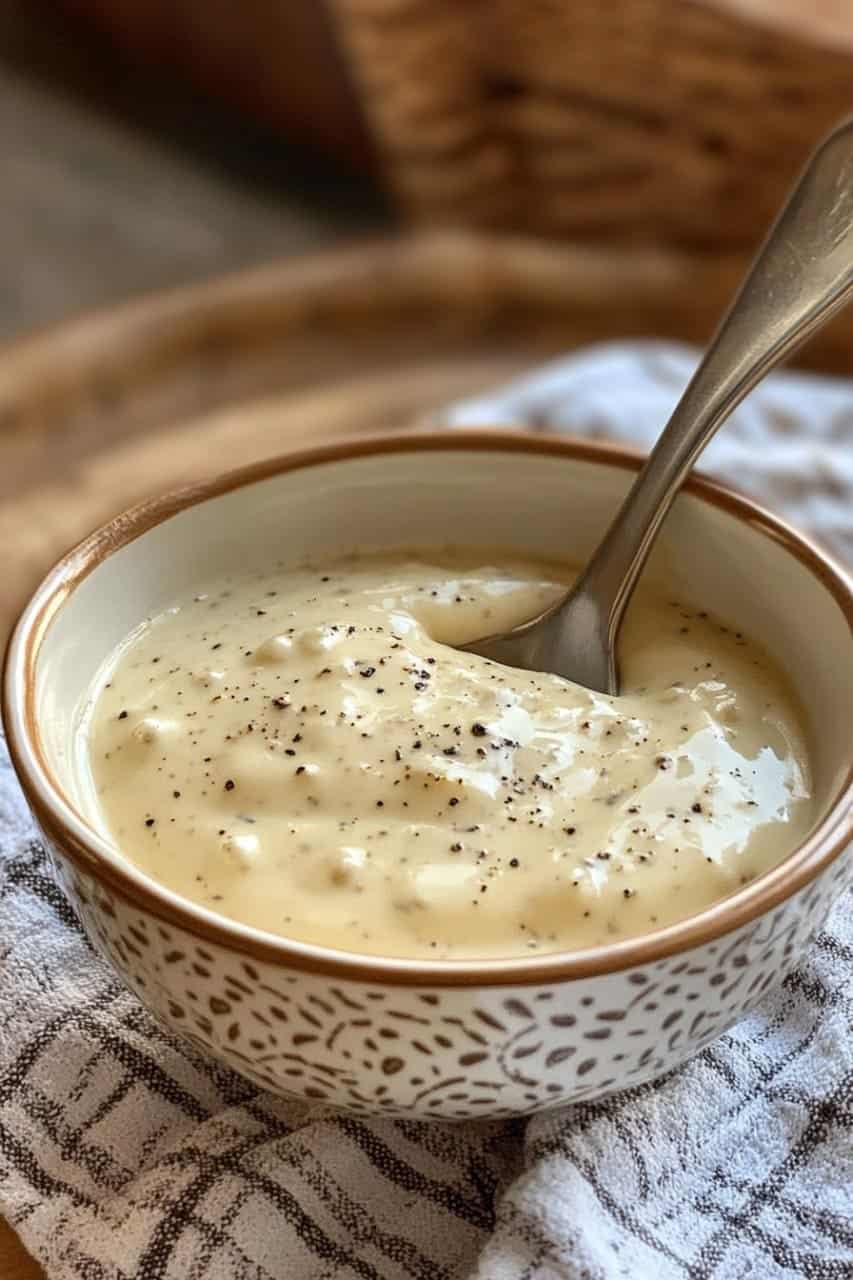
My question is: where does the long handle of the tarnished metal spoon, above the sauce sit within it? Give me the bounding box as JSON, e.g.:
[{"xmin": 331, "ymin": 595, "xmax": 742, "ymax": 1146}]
[{"xmin": 573, "ymin": 116, "xmax": 853, "ymax": 684}]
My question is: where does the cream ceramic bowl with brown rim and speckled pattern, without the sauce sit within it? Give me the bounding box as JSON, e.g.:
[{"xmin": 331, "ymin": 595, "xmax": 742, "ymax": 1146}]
[{"xmin": 4, "ymin": 430, "xmax": 853, "ymax": 1119}]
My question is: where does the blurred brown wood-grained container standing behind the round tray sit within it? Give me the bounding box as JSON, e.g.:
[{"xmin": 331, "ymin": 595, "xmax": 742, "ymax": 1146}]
[{"xmin": 333, "ymin": 0, "xmax": 853, "ymax": 248}]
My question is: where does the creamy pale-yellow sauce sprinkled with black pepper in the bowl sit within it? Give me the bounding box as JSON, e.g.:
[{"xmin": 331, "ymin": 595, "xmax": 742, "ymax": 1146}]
[{"xmin": 88, "ymin": 554, "xmax": 812, "ymax": 957}]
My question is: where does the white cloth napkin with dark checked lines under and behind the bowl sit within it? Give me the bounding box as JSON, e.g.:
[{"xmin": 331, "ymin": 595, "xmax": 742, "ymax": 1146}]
[{"xmin": 0, "ymin": 343, "xmax": 853, "ymax": 1280}]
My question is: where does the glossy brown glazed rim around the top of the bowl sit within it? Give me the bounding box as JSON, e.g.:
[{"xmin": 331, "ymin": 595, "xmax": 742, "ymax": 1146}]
[{"xmin": 3, "ymin": 428, "xmax": 853, "ymax": 987}]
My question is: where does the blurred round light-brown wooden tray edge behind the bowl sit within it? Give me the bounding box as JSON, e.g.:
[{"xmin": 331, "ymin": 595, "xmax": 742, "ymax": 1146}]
[{"xmin": 0, "ymin": 233, "xmax": 758, "ymax": 641}]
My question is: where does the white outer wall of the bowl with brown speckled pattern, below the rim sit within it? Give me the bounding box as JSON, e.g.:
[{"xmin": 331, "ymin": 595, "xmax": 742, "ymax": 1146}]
[{"xmin": 46, "ymin": 838, "xmax": 853, "ymax": 1120}]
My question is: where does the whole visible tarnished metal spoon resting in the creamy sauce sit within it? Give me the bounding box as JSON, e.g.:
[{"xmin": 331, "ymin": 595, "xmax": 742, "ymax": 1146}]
[{"xmin": 461, "ymin": 116, "xmax": 853, "ymax": 694}]
